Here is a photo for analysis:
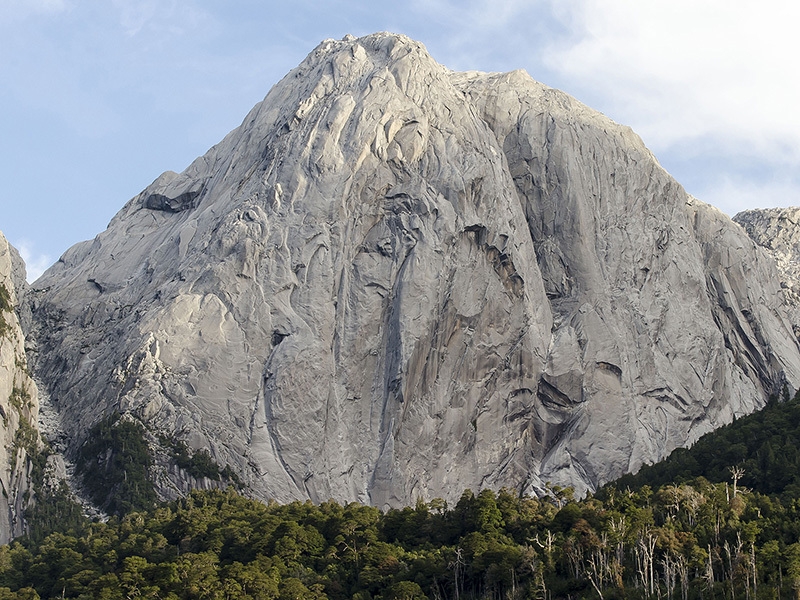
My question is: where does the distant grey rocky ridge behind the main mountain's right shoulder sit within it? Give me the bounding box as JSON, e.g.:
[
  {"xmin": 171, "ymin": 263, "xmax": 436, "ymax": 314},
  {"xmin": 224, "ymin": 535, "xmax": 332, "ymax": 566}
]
[{"xmin": 733, "ymin": 207, "xmax": 800, "ymax": 310}]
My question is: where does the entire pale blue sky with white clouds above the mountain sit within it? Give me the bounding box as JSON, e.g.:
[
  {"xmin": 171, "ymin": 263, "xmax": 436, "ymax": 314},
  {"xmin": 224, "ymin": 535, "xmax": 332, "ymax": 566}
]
[{"xmin": 0, "ymin": 0, "xmax": 800, "ymax": 278}]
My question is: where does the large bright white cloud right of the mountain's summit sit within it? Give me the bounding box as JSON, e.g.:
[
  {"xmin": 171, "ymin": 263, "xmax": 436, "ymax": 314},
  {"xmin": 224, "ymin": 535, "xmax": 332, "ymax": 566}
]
[{"xmin": 545, "ymin": 0, "xmax": 800, "ymax": 160}]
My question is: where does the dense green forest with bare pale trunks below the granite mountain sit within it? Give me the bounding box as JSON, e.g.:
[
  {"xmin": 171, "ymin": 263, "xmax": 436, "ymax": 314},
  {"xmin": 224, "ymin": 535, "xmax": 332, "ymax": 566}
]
[{"xmin": 0, "ymin": 397, "xmax": 800, "ymax": 600}]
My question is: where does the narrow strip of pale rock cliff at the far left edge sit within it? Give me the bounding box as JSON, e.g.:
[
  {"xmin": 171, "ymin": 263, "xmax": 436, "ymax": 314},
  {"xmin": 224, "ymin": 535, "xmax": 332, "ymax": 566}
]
[{"xmin": 0, "ymin": 233, "xmax": 40, "ymax": 544}]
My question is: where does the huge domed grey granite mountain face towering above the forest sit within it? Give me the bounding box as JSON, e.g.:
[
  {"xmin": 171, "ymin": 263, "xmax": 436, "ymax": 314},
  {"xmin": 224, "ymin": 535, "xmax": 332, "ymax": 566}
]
[{"xmin": 34, "ymin": 34, "xmax": 800, "ymax": 506}]
